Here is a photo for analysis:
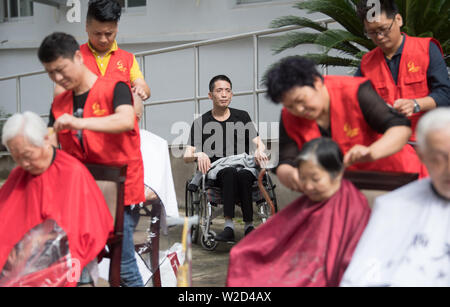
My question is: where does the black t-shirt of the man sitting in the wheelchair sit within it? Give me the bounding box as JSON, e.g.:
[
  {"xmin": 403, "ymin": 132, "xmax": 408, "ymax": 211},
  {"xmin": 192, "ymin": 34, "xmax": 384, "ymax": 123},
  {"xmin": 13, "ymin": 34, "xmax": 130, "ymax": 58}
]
[{"xmin": 188, "ymin": 108, "xmax": 258, "ymax": 162}]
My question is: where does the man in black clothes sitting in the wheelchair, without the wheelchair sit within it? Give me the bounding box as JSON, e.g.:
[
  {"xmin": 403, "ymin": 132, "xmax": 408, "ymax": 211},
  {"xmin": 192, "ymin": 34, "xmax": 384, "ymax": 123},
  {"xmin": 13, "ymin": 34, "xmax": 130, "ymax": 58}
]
[{"xmin": 184, "ymin": 75, "xmax": 267, "ymax": 242}]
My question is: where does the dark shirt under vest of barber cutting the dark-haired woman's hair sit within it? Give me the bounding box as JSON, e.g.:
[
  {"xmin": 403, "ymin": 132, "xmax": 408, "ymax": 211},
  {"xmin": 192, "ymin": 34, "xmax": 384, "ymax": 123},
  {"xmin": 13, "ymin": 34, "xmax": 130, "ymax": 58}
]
[{"xmin": 278, "ymin": 81, "xmax": 411, "ymax": 167}]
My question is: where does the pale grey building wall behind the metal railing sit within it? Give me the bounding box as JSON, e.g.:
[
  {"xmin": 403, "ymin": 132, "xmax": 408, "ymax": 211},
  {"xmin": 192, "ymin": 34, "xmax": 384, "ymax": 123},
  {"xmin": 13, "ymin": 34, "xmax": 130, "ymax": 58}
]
[{"xmin": 0, "ymin": 0, "xmax": 330, "ymax": 143}]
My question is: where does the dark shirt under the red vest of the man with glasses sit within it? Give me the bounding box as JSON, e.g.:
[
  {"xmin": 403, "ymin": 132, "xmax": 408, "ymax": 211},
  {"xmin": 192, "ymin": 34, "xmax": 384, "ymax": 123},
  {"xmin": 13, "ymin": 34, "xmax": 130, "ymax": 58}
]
[{"xmin": 355, "ymin": 36, "xmax": 450, "ymax": 107}]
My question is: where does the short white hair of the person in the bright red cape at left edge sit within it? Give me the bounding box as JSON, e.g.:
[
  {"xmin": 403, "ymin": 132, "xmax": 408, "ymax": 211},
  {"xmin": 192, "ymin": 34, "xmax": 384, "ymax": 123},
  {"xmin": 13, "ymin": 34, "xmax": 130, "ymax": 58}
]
[{"xmin": 2, "ymin": 111, "xmax": 48, "ymax": 150}]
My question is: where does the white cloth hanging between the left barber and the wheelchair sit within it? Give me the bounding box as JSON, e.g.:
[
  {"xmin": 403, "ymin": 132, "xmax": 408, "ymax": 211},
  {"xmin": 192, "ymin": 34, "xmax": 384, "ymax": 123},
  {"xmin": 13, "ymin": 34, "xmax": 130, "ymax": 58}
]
[{"xmin": 140, "ymin": 129, "xmax": 179, "ymax": 217}]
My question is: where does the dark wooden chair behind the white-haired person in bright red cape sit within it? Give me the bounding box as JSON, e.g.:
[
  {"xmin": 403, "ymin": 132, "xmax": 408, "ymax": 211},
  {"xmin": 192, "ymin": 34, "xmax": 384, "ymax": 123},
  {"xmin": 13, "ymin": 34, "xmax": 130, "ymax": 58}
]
[{"xmin": 86, "ymin": 164, "xmax": 127, "ymax": 287}]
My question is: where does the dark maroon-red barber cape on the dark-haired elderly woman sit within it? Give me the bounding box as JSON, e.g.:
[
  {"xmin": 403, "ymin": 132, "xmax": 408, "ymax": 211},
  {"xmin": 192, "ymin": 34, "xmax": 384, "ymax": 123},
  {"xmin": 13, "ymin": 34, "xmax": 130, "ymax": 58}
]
[{"xmin": 227, "ymin": 180, "xmax": 370, "ymax": 287}]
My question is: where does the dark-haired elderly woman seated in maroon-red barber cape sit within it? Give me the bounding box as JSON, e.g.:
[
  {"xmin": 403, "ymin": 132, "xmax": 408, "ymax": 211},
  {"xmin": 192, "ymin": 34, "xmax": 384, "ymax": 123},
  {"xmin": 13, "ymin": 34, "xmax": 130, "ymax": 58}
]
[{"xmin": 227, "ymin": 138, "xmax": 370, "ymax": 287}]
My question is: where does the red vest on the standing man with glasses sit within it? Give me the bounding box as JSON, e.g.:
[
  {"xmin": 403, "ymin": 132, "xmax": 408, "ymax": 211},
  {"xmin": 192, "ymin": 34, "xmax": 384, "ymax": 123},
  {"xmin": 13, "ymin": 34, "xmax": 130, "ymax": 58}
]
[{"xmin": 361, "ymin": 34, "xmax": 443, "ymax": 141}]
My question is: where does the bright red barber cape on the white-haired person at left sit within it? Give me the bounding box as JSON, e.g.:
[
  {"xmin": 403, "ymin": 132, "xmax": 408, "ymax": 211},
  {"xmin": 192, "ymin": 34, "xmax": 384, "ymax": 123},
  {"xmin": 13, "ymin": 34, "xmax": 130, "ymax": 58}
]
[{"xmin": 0, "ymin": 150, "xmax": 113, "ymax": 286}]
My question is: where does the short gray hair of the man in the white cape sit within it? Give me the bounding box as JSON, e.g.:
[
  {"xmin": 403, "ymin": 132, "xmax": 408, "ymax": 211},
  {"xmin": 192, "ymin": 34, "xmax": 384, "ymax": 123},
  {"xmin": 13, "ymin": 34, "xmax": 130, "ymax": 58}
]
[{"xmin": 416, "ymin": 107, "xmax": 450, "ymax": 149}]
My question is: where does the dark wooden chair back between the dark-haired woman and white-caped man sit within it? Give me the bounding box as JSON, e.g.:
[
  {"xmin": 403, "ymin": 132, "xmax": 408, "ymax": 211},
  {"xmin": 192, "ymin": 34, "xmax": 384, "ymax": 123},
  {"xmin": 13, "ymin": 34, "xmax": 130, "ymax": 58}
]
[{"xmin": 344, "ymin": 171, "xmax": 419, "ymax": 191}]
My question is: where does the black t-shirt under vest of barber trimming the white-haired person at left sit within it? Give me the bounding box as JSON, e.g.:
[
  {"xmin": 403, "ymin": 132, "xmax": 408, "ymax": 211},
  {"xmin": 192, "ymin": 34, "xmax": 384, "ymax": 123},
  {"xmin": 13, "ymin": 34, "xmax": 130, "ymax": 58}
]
[{"xmin": 48, "ymin": 82, "xmax": 132, "ymax": 127}]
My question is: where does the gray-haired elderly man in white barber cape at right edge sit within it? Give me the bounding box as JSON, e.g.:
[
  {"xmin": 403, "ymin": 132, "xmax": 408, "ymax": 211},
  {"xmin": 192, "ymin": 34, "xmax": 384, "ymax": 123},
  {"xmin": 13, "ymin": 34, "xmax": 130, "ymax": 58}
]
[{"xmin": 341, "ymin": 108, "xmax": 450, "ymax": 287}]
